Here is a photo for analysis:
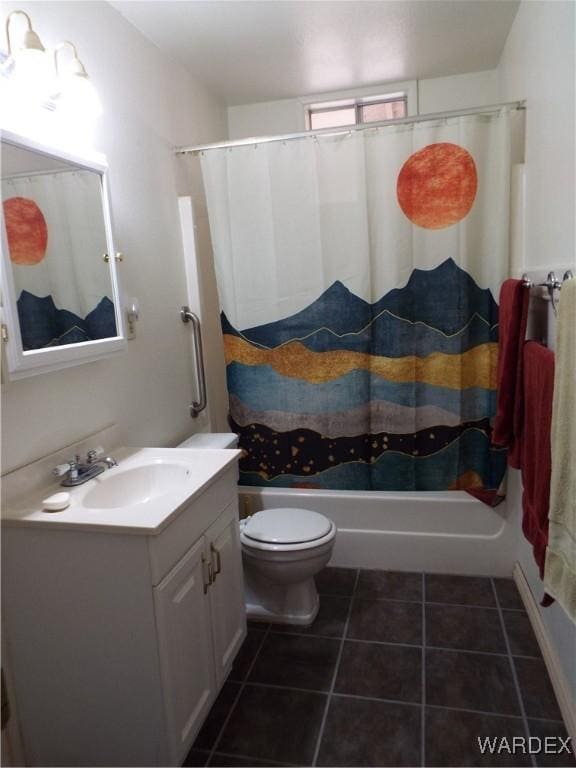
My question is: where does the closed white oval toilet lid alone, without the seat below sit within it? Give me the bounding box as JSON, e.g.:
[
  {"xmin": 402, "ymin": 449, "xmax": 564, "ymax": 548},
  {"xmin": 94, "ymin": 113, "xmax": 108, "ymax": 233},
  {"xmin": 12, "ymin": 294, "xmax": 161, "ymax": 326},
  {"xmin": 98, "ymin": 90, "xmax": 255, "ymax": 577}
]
[{"xmin": 243, "ymin": 507, "xmax": 332, "ymax": 544}]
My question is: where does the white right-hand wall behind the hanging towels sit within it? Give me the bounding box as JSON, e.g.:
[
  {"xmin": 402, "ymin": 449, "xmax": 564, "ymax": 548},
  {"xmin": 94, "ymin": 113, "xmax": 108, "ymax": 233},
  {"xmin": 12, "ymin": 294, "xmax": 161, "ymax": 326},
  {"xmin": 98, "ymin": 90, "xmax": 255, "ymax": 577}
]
[{"xmin": 498, "ymin": 0, "xmax": 576, "ymax": 702}]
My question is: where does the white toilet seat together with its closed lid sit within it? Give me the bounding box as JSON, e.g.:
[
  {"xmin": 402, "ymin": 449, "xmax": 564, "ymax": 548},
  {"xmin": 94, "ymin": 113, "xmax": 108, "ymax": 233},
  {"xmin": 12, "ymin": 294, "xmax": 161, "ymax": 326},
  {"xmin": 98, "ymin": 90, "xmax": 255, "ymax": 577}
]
[{"xmin": 240, "ymin": 507, "xmax": 336, "ymax": 552}]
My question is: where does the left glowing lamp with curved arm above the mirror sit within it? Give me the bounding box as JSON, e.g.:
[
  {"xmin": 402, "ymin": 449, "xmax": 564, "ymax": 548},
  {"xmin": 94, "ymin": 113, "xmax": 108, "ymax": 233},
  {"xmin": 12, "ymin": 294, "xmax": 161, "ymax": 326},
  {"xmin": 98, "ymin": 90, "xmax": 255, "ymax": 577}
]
[{"xmin": 5, "ymin": 11, "xmax": 51, "ymax": 100}]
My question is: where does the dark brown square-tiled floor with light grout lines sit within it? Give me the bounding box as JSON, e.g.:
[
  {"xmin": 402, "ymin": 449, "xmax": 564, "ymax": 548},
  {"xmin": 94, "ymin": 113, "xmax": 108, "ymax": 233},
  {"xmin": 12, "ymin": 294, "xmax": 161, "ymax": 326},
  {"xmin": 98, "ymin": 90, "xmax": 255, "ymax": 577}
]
[{"xmin": 184, "ymin": 568, "xmax": 576, "ymax": 766}]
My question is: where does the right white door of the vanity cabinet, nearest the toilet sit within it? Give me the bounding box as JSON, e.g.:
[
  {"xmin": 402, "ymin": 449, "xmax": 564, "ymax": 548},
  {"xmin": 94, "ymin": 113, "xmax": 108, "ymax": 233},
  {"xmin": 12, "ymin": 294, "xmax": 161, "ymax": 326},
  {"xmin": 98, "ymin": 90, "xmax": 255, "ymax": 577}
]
[{"xmin": 206, "ymin": 503, "xmax": 246, "ymax": 685}]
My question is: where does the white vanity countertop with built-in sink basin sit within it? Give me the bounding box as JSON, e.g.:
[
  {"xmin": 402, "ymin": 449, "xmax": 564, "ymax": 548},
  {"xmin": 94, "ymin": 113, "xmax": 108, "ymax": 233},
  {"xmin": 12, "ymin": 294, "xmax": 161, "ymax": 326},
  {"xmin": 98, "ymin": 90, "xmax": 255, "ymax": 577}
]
[{"xmin": 2, "ymin": 448, "xmax": 241, "ymax": 535}]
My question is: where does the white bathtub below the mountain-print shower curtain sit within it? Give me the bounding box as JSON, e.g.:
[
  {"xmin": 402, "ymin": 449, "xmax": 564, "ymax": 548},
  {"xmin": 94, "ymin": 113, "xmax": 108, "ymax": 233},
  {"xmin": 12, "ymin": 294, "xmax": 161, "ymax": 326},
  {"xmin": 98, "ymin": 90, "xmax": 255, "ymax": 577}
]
[{"xmin": 238, "ymin": 486, "xmax": 519, "ymax": 576}]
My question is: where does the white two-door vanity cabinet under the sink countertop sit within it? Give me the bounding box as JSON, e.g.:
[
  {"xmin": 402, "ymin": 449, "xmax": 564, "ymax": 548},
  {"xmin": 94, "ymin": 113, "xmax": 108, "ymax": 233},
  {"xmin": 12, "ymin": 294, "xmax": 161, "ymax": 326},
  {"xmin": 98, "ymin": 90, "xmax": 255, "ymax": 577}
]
[{"xmin": 2, "ymin": 463, "xmax": 246, "ymax": 766}]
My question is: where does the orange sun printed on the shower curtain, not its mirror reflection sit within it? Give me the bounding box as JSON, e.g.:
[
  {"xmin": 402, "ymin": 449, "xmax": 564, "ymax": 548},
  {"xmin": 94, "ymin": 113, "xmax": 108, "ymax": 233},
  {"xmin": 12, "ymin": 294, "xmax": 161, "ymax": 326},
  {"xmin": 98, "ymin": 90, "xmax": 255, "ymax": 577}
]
[{"xmin": 396, "ymin": 142, "xmax": 478, "ymax": 229}]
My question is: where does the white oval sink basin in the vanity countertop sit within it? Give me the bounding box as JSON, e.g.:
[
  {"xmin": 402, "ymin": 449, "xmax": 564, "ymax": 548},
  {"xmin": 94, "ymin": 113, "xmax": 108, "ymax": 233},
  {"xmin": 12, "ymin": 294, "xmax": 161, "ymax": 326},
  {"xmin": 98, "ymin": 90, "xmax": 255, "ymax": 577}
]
[{"xmin": 82, "ymin": 461, "xmax": 191, "ymax": 509}]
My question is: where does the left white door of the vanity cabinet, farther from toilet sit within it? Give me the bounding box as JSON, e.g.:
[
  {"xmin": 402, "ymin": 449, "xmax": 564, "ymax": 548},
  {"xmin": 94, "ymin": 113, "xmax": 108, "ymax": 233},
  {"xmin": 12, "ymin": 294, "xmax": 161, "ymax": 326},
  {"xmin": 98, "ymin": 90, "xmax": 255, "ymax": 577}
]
[{"xmin": 154, "ymin": 538, "xmax": 216, "ymax": 765}]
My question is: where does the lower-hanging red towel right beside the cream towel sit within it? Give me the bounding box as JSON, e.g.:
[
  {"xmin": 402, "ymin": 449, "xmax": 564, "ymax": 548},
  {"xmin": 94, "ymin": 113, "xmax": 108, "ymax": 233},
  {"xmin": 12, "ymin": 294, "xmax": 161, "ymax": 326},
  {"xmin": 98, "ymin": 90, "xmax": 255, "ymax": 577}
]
[{"xmin": 522, "ymin": 341, "xmax": 554, "ymax": 577}]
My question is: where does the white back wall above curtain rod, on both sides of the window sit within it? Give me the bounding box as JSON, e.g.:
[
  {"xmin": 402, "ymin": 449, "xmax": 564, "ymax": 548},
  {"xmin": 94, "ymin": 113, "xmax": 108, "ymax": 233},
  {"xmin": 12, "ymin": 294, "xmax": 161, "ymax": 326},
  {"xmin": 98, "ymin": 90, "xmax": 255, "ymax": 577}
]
[{"xmin": 228, "ymin": 70, "xmax": 498, "ymax": 139}]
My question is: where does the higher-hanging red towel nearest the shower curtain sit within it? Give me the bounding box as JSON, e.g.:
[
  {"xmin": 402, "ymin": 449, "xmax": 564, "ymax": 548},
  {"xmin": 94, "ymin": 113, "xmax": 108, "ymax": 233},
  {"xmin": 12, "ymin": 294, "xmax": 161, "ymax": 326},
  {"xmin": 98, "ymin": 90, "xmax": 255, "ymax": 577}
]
[{"xmin": 492, "ymin": 280, "xmax": 530, "ymax": 469}]
